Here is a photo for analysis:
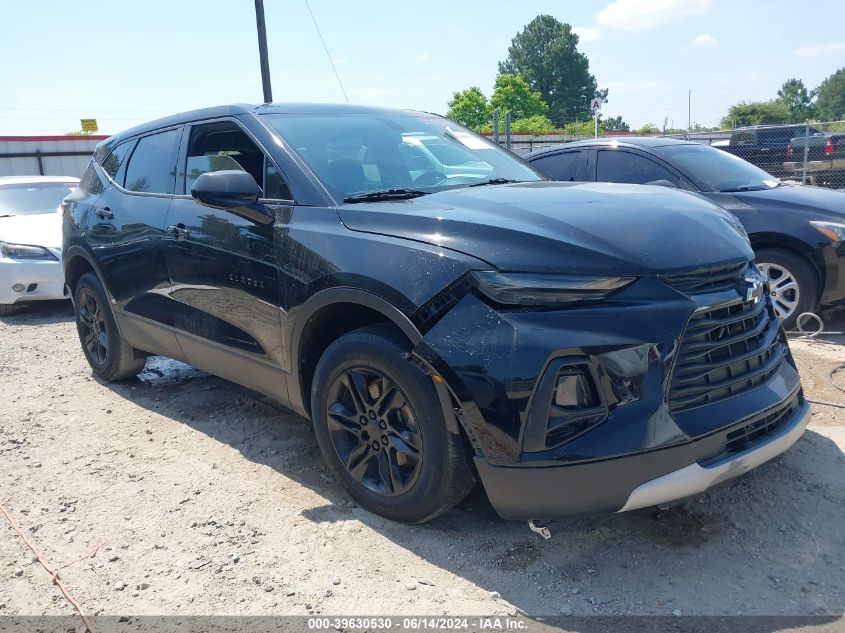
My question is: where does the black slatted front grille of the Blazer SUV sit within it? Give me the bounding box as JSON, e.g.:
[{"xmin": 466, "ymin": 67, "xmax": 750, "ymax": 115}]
[{"xmin": 669, "ymin": 296, "xmax": 786, "ymax": 411}]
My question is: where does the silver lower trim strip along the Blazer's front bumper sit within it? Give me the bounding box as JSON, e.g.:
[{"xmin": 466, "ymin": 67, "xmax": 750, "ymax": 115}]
[{"xmin": 618, "ymin": 403, "xmax": 810, "ymax": 512}]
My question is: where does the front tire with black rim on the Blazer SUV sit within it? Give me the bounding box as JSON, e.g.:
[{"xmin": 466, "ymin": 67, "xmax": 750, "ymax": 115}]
[{"xmin": 311, "ymin": 325, "xmax": 475, "ymax": 523}]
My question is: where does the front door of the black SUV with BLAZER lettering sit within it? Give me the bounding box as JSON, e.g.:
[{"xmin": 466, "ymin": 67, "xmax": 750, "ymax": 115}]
[{"xmin": 165, "ymin": 119, "xmax": 289, "ymax": 402}]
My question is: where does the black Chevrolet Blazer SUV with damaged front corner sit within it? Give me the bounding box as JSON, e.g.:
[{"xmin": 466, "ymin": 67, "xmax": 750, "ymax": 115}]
[{"xmin": 63, "ymin": 105, "xmax": 809, "ymax": 522}]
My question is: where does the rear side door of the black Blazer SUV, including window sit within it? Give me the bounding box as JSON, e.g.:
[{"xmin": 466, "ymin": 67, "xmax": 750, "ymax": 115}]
[{"xmin": 89, "ymin": 127, "xmax": 181, "ymax": 355}]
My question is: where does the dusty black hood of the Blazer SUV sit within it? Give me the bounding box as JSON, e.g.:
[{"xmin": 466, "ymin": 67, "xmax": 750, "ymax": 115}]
[{"xmin": 338, "ymin": 181, "xmax": 753, "ymax": 275}]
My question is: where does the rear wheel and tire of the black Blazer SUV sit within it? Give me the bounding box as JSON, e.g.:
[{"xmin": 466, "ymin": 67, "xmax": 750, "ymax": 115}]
[{"xmin": 74, "ymin": 273, "xmax": 147, "ymax": 382}]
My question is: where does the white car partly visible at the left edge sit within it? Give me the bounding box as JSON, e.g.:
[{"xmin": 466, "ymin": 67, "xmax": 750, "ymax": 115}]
[{"xmin": 0, "ymin": 176, "xmax": 79, "ymax": 316}]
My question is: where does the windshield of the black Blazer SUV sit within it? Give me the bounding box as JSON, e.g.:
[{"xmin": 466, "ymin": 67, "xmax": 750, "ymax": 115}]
[{"xmin": 264, "ymin": 113, "xmax": 543, "ymax": 199}]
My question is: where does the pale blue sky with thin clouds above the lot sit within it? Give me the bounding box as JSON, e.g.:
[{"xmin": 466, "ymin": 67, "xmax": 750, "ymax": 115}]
[{"xmin": 0, "ymin": 0, "xmax": 845, "ymax": 134}]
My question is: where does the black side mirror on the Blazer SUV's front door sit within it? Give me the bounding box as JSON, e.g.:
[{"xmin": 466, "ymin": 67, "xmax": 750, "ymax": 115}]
[{"xmin": 191, "ymin": 169, "xmax": 275, "ymax": 224}]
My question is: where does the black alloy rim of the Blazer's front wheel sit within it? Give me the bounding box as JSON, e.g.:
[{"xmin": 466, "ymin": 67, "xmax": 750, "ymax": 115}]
[{"xmin": 326, "ymin": 367, "xmax": 422, "ymax": 497}]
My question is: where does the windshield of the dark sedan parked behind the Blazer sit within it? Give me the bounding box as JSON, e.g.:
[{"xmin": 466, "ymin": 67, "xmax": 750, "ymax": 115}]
[{"xmin": 655, "ymin": 144, "xmax": 780, "ymax": 191}]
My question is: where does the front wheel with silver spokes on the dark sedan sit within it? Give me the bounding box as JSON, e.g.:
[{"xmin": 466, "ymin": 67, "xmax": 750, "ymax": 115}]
[{"xmin": 756, "ymin": 248, "xmax": 819, "ymax": 330}]
